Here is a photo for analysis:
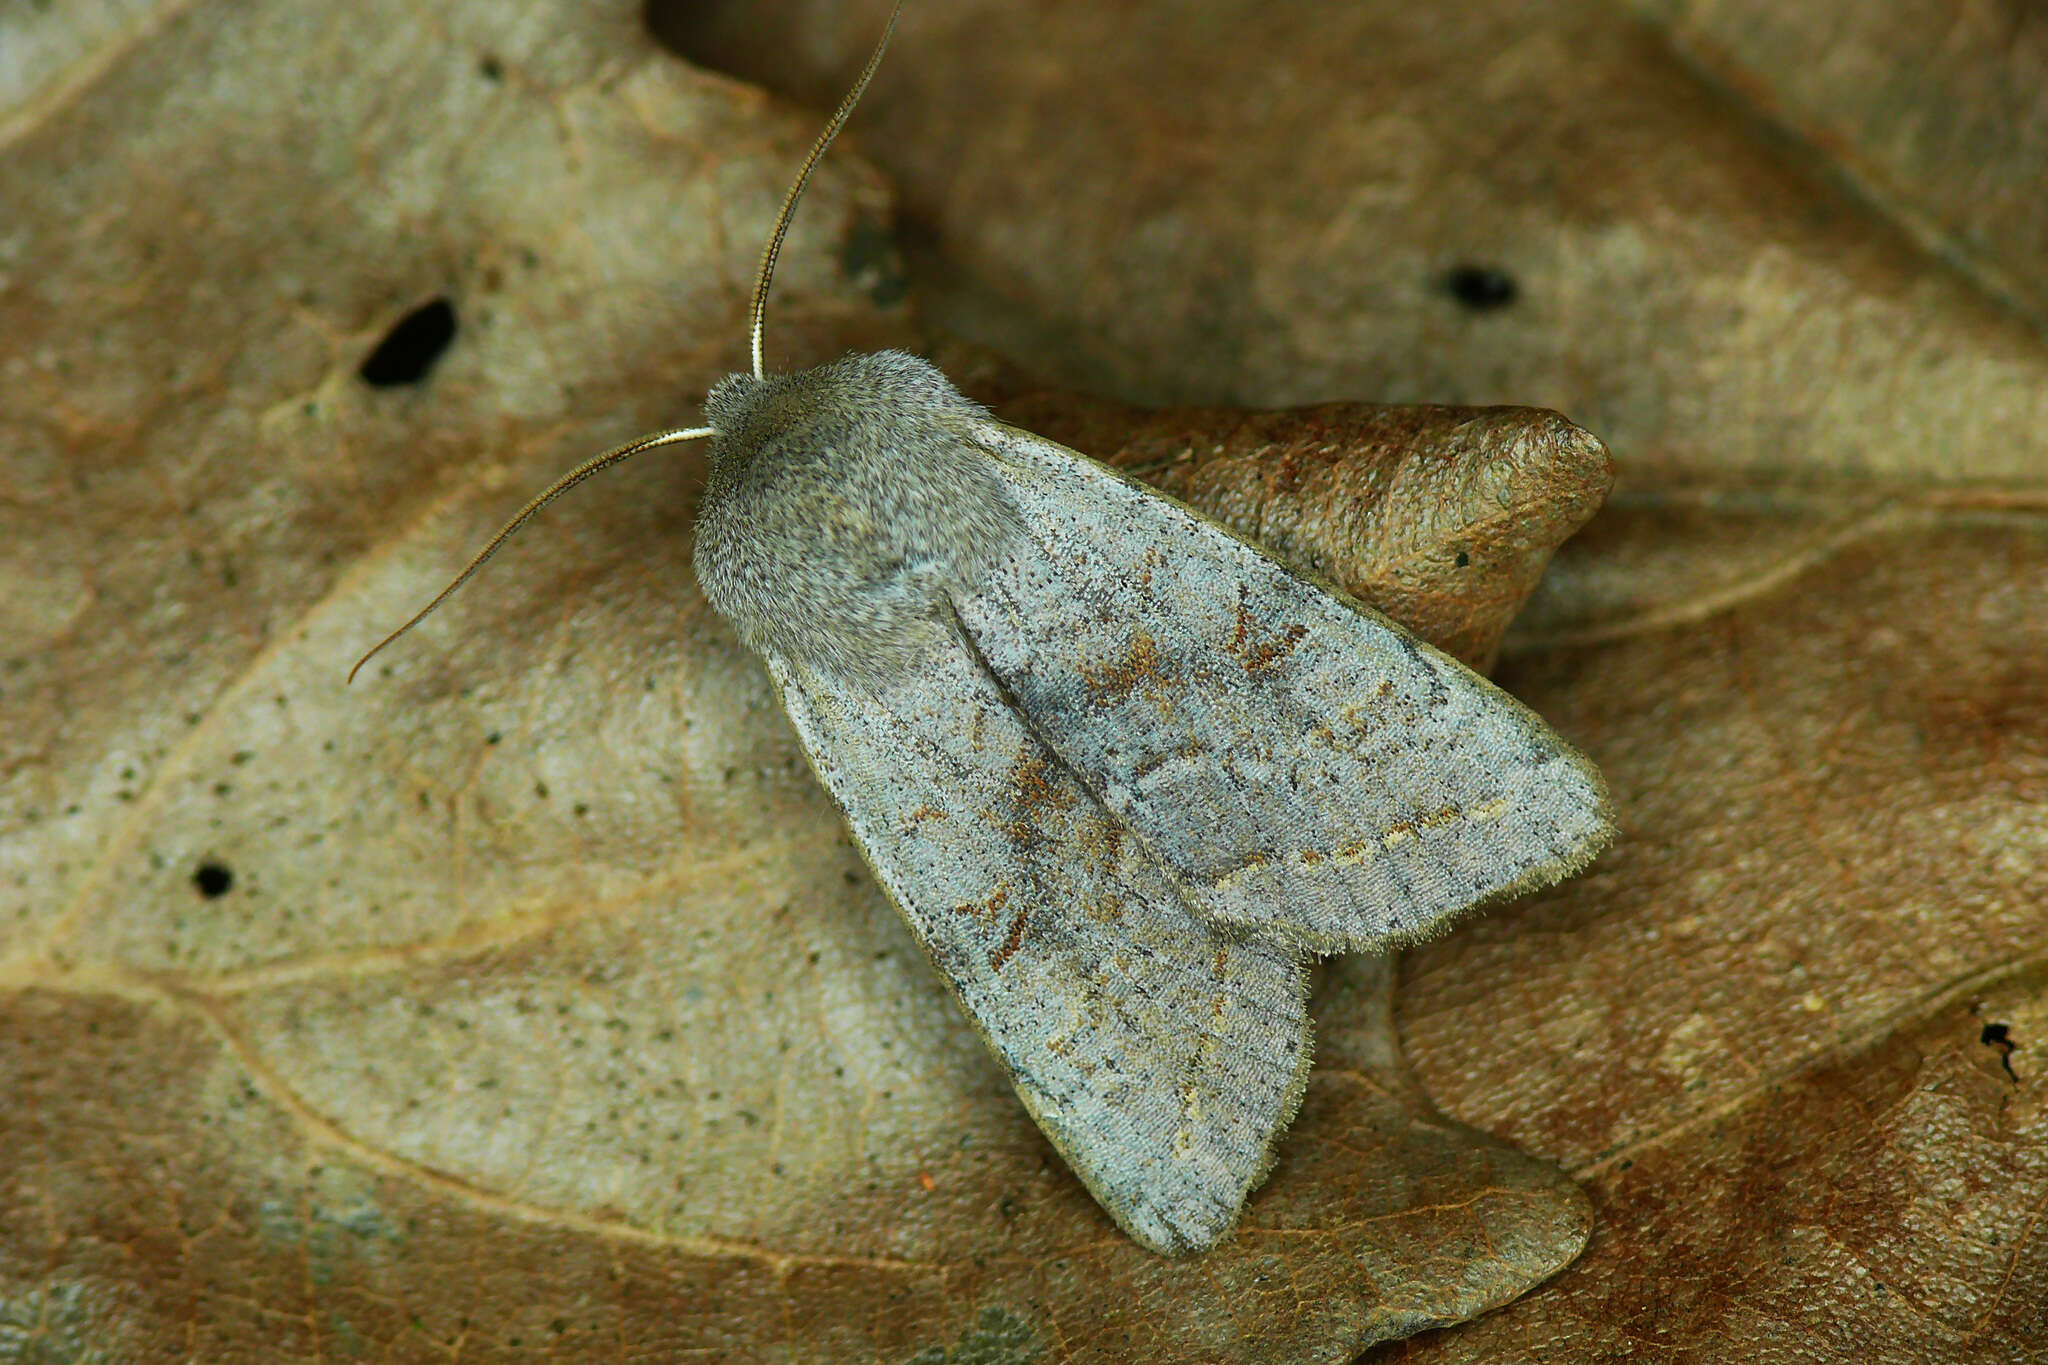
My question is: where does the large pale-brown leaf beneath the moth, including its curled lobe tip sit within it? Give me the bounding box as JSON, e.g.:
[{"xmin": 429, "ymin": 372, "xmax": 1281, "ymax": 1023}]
[{"xmin": 0, "ymin": 4, "xmax": 1610, "ymax": 1361}]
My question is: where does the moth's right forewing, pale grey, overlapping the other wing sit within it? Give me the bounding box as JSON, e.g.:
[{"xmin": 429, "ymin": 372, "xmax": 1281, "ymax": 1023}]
[{"xmin": 961, "ymin": 422, "xmax": 1614, "ymax": 954}]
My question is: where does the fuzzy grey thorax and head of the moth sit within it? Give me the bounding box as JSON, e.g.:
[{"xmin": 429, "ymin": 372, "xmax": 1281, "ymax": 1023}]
[{"xmin": 696, "ymin": 350, "xmax": 1020, "ymax": 681}]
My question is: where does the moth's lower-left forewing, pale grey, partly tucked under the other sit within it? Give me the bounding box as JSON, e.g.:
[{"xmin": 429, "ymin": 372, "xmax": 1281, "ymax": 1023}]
[{"xmin": 768, "ymin": 636, "xmax": 1309, "ymax": 1254}]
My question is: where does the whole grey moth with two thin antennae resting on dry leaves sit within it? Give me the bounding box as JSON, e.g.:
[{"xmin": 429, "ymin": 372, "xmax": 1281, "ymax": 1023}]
[{"xmin": 350, "ymin": 0, "xmax": 1614, "ymax": 1254}]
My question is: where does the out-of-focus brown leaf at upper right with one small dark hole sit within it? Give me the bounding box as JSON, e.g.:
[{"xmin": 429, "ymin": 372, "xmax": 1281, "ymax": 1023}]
[{"xmin": 671, "ymin": 0, "xmax": 2048, "ymax": 485}]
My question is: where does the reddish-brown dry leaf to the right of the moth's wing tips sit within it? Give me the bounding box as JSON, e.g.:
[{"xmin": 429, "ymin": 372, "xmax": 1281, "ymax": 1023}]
[{"xmin": 1384, "ymin": 489, "xmax": 2048, "ymax": 1365}]
